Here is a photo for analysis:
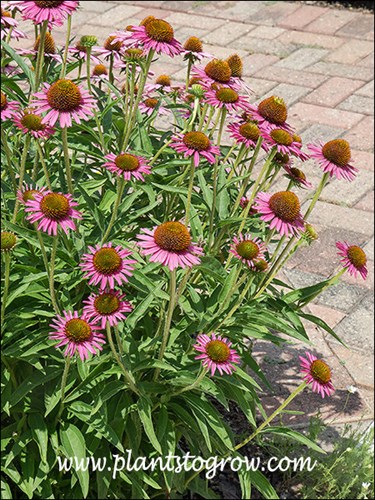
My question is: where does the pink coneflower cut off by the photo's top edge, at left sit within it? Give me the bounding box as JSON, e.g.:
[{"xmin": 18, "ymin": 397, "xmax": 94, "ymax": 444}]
[{"xmin": 9, "ymin": 0, "xmax": 79, "ymax": 27}]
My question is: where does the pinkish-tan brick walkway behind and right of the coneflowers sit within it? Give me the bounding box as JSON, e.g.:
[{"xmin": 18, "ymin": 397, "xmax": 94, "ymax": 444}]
[{"xmin": 13, "ymin": 1, "xmax": 374, "ymax": 430}]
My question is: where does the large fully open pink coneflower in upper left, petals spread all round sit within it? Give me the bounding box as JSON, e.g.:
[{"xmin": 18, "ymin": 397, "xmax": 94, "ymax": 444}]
[{"xmin": 32, "ymin": 79, "xmax": 96, "ymax": 127}]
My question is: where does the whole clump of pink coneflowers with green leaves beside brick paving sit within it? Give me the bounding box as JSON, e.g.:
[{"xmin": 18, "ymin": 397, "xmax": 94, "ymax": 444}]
[{"xmin": 1, "ymin": 1, "xmax": 367, "ymax": 499}]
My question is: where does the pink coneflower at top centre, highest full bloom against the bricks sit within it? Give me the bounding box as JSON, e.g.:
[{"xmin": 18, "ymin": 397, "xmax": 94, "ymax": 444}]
[{"xmin": 127, "ymin": 16, "xmax": 182, "ymax": 57}]
